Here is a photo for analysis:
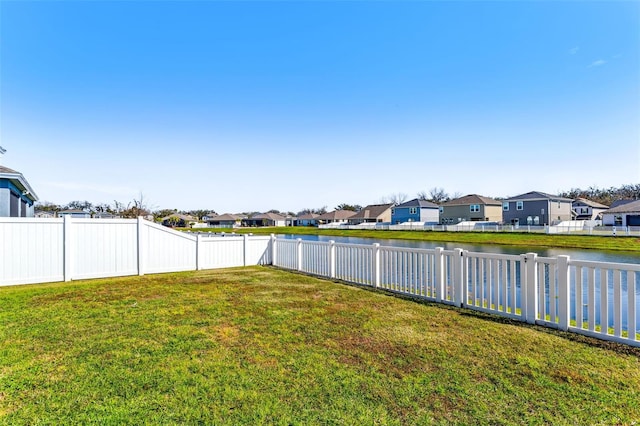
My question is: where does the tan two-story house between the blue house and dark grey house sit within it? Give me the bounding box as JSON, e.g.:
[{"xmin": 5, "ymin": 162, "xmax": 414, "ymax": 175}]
[{"xmin": 440, "ymin": 194, "xmax": 502, "ymax": 225}]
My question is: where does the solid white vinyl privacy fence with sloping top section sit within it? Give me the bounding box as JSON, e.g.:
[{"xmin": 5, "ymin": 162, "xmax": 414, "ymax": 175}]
[{"xmin": 0, "ymin": 216, "xmax": 271, "ymax": 285}]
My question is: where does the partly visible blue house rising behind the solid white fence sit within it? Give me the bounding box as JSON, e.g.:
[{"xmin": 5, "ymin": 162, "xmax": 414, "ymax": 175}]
[{"xmin": 0, "ymin": 147, "xmax": 38, "ymax": 217}]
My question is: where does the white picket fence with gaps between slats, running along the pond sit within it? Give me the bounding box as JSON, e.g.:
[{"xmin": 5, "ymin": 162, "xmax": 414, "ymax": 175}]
[{"xmin": 272, "ymin": 237, "xmax": 640, "ymax": 346}]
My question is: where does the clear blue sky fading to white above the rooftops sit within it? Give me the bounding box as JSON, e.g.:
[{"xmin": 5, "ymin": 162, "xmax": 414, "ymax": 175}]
[{"xmin": 0, "ymin": 0, "xmax": 640, "ymax": 213}]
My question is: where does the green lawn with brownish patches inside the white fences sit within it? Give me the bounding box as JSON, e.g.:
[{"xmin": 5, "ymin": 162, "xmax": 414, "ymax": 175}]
[{"xmin": 0, "ymin": 267, "xmax": 640, "ymax": 425}]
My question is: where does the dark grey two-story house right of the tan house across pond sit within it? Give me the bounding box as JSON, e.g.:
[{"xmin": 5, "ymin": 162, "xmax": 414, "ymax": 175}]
[{"xmin": 502, "ymin": 191, "xmax": 573, "ymax": 225}]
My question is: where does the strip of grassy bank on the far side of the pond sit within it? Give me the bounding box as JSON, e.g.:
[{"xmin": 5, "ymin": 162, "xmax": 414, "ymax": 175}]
[{"xmin": 192, "ymin": 226, "xmax": 640, "ymax": 253}]
